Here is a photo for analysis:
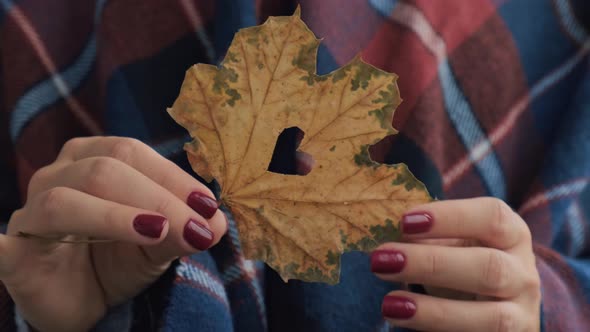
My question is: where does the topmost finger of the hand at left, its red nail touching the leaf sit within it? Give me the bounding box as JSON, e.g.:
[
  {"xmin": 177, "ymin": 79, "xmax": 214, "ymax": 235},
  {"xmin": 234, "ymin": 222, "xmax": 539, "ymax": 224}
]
[{"xmin": 58, "ymin": 136, "xmax": 222, "ymax": 219}]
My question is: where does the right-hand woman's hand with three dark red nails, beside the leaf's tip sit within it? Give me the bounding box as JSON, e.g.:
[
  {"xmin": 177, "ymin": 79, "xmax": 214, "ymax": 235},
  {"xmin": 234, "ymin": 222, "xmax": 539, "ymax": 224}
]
[{"xmin": 371, "ymin": 198, "xmax": 541, "ymax": 332}]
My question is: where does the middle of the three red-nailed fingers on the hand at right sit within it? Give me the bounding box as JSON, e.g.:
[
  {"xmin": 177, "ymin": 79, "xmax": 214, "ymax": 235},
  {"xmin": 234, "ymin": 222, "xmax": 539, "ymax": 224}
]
[{"xmin": 371, "ymin": 243, "xmax": 529, "ymax": 298}]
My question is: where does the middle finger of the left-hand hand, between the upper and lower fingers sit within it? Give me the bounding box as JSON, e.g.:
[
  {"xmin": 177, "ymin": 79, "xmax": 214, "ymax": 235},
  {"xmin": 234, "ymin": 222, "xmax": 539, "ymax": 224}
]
[{"xmin": 35, "ymin": 157, "xmax": 227, "ymax": 262}]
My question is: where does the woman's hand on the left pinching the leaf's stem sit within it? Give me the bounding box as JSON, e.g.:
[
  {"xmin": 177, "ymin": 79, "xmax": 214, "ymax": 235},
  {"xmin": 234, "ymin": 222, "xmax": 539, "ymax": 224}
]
[{"xmin": 0, "ymin": 137, "xmax": 227, "ymax": 331}]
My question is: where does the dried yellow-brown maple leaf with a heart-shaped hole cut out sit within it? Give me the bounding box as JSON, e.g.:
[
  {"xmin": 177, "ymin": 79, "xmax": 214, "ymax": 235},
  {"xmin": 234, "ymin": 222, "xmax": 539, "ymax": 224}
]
[{"xmin": 169, "ymin": 9, "xmax": 430, "ymax": 283}]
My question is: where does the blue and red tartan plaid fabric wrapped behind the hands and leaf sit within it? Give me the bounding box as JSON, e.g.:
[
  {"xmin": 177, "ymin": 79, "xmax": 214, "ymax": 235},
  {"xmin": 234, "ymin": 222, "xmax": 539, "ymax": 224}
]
[{"xmin": 0, "ymin": 0, "xmax": 590, "ymax": 331}]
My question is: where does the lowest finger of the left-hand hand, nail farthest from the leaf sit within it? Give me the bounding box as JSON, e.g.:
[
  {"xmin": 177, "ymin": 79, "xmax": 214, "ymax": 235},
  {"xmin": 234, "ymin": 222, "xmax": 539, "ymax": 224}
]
[{"xmin": 11, "ymin": 187, "xmax": 169, "ymax": 245}]
